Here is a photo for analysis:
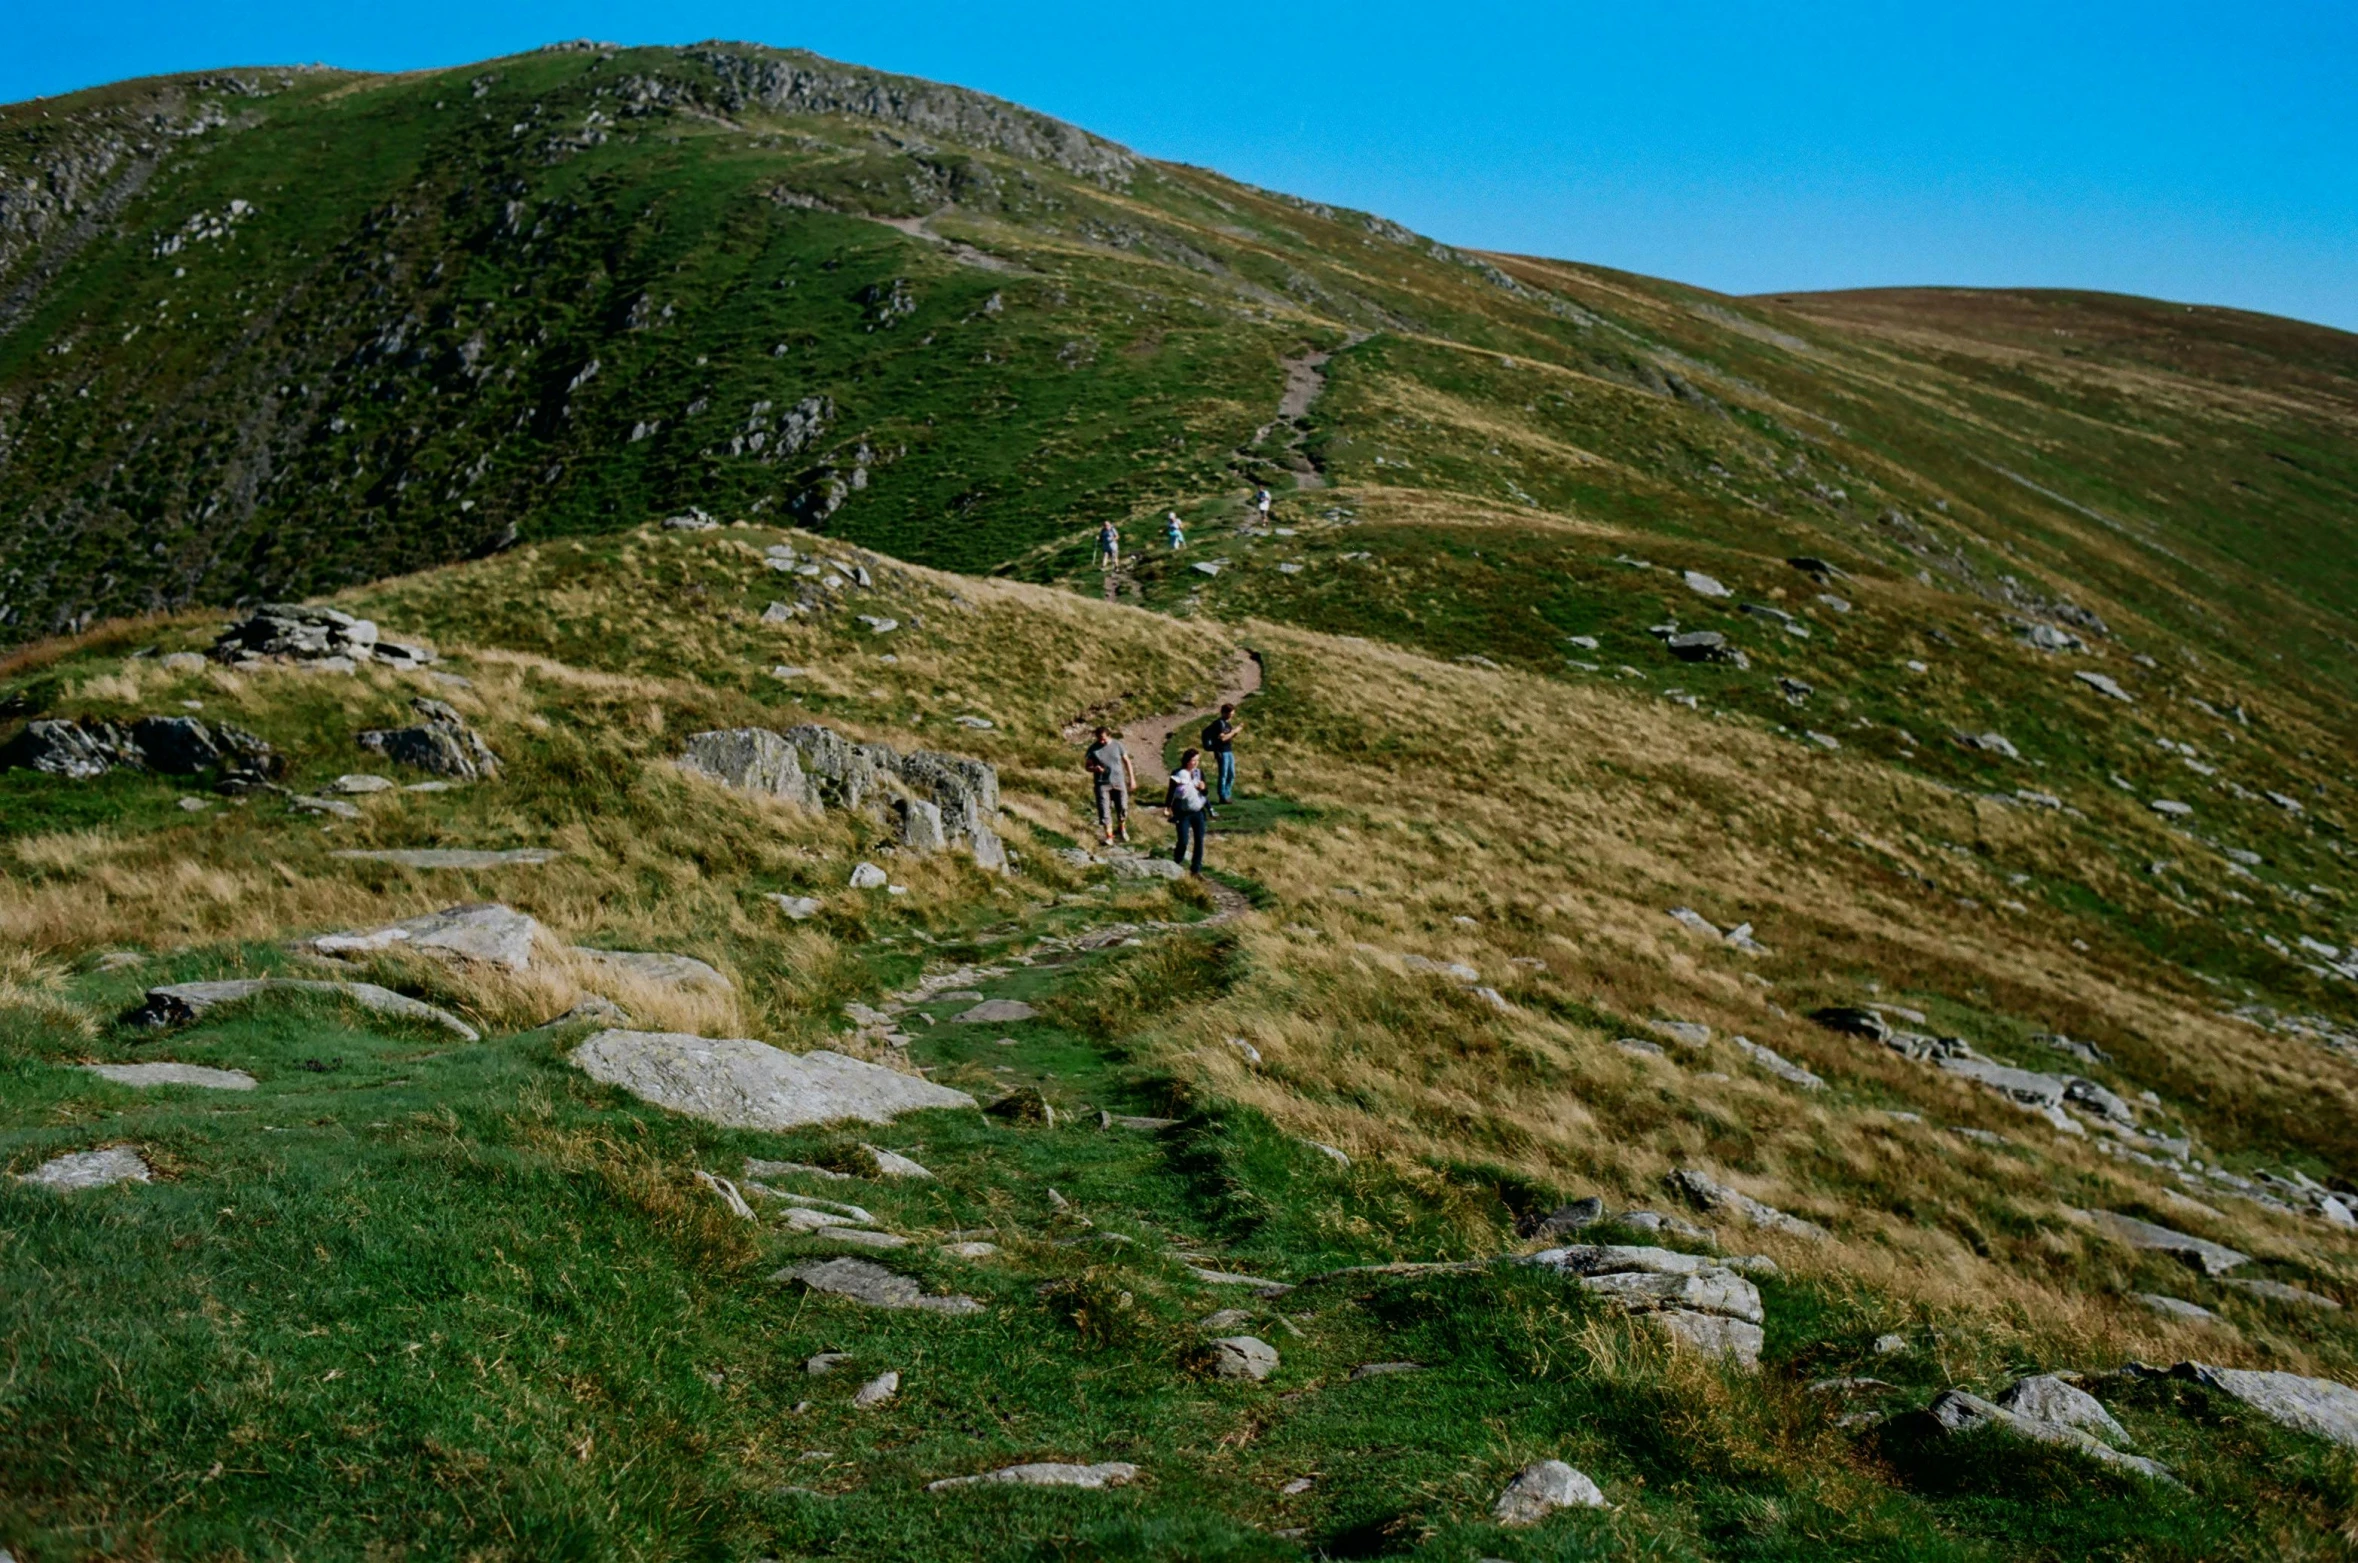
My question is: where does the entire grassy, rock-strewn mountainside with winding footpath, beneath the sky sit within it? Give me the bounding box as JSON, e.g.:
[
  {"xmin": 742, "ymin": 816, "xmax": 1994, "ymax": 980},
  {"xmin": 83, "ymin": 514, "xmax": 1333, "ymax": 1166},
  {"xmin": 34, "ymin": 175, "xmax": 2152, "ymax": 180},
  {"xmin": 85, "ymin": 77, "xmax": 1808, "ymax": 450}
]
[{"xmin": 0, "ymin": 42, "xmax": 2358, "ymax": 1563}]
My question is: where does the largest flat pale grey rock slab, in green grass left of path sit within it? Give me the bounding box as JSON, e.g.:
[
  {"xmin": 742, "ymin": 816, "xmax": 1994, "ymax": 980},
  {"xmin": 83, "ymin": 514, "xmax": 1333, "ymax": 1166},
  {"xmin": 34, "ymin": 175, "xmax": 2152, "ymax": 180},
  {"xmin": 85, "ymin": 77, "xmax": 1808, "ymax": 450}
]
[{"xmin": 573, "ymin": 1030, "xmax": 976, "ymax": 1129}]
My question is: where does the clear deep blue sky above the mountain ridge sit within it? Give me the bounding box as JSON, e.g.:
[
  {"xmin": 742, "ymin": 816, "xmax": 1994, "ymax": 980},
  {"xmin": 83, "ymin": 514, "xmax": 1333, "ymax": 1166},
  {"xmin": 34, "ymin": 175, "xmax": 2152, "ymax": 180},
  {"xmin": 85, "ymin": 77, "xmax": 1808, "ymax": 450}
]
[{"xmin": 18, "ymin": 0, "xmax": 2358, "ymax": 330}]
